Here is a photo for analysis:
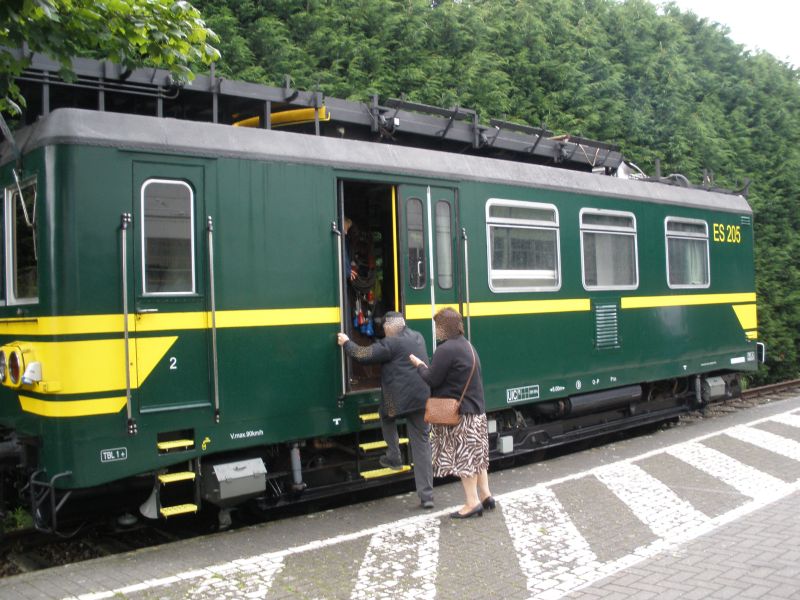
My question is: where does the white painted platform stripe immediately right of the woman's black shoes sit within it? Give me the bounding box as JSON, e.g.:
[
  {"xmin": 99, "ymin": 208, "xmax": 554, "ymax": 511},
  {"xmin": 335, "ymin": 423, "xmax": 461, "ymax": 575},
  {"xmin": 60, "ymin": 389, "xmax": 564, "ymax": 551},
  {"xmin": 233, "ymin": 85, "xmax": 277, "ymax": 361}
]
[{"xmin": 501, "ymin": 486, "xmax": 600, "ymax": 599}]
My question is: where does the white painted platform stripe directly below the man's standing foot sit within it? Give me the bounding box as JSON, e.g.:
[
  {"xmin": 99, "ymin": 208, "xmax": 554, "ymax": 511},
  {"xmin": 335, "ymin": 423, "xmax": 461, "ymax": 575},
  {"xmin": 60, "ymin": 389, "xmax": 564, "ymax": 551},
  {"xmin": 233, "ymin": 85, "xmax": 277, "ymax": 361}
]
[{"xmin": 351, "ymin": 517, "xmax": 441, "ymax": 600}]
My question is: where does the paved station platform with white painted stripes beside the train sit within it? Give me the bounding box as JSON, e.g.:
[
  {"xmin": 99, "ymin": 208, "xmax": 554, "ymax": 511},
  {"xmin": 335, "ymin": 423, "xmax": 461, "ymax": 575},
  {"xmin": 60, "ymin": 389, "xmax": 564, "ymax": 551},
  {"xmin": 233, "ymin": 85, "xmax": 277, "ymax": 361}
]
[{"xmin": 0, "ymin": 397, "xmax": 800, "ymax": 600}]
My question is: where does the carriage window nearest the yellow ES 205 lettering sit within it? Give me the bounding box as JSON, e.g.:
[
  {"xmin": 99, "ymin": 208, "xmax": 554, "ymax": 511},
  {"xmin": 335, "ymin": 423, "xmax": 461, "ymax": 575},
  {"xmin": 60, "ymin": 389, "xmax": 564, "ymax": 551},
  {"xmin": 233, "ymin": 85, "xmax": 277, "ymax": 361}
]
[{"xmin": 664, "ymin": 217, "xmax": 711, "ymax": 288}]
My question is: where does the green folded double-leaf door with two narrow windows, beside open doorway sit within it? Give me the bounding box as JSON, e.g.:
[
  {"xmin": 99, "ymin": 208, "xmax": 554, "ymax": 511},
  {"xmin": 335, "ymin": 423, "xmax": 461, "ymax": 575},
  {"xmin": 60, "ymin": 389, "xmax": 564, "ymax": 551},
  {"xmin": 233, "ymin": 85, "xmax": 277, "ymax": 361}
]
[{"xmin": 399, "ymin": 185, "xmax": 460, "ymax": 352}]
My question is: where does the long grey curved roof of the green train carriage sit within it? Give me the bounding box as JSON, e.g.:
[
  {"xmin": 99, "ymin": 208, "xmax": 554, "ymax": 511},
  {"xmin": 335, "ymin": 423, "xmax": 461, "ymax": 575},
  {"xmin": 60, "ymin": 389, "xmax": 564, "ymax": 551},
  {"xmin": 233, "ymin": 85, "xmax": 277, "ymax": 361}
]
[{"xmin": 0, "ymin": 109, "xmax": 751, "ymax": 214}]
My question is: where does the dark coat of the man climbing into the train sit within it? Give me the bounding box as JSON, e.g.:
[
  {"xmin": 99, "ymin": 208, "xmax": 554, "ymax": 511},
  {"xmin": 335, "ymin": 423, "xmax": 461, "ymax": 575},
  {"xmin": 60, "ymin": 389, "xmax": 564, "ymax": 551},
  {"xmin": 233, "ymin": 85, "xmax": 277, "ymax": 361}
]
[{"xmin": 344, "ymin": 327, "xmax": 430, "ymax": 417}]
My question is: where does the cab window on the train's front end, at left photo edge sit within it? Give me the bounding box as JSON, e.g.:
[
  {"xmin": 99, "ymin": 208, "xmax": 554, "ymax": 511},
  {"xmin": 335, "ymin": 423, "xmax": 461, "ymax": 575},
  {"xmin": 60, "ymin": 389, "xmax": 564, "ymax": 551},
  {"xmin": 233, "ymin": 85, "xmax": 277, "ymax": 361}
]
[{"xmin": 5, "ymin": 177, "xmax": 39, "ymax": 304}]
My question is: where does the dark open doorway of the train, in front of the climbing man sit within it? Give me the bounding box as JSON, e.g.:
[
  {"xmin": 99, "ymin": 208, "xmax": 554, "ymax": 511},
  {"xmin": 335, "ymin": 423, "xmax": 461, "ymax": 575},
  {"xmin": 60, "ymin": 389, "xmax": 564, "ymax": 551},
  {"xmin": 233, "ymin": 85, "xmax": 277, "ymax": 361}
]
[{"xmin": 341, "ymin": 181, "xmax": 400, "ymax": 392}]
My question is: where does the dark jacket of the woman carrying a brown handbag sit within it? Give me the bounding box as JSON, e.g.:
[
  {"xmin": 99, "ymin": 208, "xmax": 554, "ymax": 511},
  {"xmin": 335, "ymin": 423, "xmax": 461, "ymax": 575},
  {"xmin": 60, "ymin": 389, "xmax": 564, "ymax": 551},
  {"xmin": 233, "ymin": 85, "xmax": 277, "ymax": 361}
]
[{"xmin": 417, "ymin": 335, "xmax": 486, "ymax": 415}]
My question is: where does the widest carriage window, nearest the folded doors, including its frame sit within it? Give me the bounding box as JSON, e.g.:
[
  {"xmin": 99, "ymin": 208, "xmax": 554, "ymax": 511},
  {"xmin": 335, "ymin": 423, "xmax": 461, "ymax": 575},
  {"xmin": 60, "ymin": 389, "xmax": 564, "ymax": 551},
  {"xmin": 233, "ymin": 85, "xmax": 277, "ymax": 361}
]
[{"xmin": 486, "ymin": 198, "xmax": 561, "ymax": 292}]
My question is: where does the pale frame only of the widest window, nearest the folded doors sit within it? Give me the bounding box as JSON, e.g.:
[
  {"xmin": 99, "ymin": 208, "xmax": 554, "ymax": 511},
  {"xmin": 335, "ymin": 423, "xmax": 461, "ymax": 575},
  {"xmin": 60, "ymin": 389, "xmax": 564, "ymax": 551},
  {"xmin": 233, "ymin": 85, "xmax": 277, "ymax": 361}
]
[{"xmin": 485, "ymin": 198, "xmax": 562, "ymax": 294}]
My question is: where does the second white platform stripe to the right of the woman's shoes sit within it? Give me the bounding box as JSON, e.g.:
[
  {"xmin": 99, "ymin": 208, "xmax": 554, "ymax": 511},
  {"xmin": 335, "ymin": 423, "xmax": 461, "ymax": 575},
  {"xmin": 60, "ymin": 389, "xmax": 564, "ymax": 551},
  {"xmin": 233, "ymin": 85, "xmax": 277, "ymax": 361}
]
[{"xmin": 594, "ymin": 462, "xmax": 709, "ymax": 539}]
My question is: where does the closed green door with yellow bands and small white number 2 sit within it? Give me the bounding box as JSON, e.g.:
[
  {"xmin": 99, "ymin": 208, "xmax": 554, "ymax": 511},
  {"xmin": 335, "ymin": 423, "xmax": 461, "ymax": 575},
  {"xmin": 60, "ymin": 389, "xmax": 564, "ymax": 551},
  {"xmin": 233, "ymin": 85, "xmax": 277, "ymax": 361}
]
[{"xmin": 129, "ymin": 163, "xmax": 212, "ymax": 413}]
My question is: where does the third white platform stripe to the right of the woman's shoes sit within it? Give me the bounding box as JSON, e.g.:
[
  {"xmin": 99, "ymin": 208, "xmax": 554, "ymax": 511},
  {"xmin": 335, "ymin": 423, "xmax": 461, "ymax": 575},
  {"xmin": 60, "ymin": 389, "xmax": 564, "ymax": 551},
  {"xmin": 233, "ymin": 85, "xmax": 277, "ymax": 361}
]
[{"xmin": 667, "ymin": 442, "xmax": 787, "ymax": 501}]
